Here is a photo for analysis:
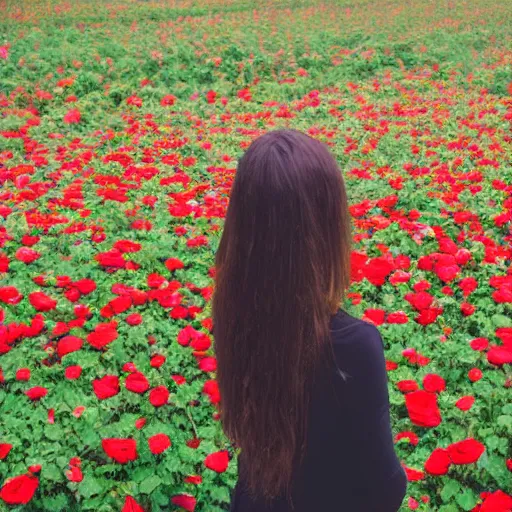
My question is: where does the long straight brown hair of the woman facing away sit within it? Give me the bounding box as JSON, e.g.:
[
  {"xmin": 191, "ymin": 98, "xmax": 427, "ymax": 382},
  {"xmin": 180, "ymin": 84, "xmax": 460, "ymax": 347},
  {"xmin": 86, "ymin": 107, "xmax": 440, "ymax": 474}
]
[{"xmin": 213, "ymin": 130, "xmax": 351, "ymax": 499}]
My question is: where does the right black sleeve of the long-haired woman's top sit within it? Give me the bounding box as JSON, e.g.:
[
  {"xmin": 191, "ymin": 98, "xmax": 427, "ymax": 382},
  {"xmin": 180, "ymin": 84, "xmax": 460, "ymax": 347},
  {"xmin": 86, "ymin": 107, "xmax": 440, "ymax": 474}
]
[{"xmin": 332, "ymin": 321, "xmax": 407, "ymax": 512}]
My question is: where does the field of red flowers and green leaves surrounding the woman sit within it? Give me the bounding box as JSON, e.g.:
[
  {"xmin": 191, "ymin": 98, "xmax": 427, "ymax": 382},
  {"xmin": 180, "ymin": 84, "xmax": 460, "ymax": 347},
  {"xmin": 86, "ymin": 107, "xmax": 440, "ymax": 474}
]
[{"xmin": 0, "ymin": 0, "xmax": 512, "ymax": 512}]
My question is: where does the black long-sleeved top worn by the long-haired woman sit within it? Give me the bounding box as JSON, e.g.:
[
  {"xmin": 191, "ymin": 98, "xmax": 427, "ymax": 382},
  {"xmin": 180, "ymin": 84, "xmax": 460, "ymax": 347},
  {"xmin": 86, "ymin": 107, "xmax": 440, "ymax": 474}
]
[{"xmin": 231, "ymin": 311, "xmax": 407, "ymax": 512}]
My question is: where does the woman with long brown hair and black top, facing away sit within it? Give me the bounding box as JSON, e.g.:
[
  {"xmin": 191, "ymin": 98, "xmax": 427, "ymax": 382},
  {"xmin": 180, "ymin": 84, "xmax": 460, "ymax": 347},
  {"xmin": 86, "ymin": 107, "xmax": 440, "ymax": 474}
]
[{"xmin": 213, "ymin": 130, "xmax": 406, "ymax": 512}]
